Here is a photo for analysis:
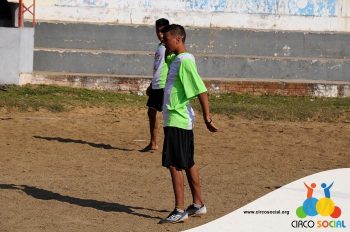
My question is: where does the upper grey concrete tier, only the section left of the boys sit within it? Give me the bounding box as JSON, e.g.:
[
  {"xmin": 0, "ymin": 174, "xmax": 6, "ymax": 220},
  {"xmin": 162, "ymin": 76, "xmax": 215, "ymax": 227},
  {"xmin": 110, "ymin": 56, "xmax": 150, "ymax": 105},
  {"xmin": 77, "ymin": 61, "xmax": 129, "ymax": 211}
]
[{"xmin": 34, "ymin": 22, "xmax": 158, "ymax": 51}]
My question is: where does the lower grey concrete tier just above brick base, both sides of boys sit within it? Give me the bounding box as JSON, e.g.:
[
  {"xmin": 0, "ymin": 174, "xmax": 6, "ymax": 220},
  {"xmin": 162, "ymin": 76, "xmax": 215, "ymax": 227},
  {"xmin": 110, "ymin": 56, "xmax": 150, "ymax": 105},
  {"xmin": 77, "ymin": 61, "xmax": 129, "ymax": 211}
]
[{"xmin": 34, "ymin": 48, "xmax": 350, "ymax": 81}]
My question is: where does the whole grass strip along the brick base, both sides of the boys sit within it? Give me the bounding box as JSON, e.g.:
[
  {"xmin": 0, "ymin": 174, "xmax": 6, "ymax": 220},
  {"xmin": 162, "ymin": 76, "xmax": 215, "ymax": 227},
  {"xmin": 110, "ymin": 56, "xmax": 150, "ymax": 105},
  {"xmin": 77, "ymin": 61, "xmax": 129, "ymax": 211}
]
[{"xmin": 0, "ymin": 85, "xmax": 350, "ymax": 122}]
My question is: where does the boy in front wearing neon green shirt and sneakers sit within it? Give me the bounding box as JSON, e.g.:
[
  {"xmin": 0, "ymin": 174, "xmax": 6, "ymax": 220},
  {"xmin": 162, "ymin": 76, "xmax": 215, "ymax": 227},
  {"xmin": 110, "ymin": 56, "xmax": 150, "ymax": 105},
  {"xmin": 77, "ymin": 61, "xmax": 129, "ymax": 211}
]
[{"xmin": 160, "ymin": 24, "xmax": 218, "ymax": 223}]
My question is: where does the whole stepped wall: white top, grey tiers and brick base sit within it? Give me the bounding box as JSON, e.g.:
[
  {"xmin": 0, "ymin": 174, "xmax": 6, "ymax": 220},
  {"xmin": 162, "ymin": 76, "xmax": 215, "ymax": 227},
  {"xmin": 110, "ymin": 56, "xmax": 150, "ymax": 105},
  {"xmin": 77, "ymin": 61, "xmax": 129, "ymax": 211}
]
[{"xmin": 14, "ymin": 0, "xmax": 350, "ymax": 96}]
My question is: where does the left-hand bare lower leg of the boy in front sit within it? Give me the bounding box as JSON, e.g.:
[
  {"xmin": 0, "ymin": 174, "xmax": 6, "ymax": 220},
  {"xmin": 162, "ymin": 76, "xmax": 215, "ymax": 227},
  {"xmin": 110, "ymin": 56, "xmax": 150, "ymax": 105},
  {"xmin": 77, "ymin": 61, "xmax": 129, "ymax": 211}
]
[{"xmin": 169, "ymin": 166, "xmax": 185, "ymax": 210}]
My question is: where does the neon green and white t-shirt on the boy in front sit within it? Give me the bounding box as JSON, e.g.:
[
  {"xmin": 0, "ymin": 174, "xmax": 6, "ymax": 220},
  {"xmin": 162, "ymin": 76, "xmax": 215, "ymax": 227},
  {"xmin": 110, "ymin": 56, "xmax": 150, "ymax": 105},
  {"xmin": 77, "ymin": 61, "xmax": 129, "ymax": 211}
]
[{"xmin": 163, "ymin": 53, "xmax": 207, "ymax": 130}]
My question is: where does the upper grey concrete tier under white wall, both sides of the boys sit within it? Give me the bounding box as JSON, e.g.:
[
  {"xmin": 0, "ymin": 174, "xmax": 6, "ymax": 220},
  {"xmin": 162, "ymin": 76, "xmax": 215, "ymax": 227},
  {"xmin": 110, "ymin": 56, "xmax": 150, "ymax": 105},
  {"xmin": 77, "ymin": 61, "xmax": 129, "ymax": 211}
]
[{"xmin": 35, "ymin": 22, "xmax": 350, "ymax": 59}]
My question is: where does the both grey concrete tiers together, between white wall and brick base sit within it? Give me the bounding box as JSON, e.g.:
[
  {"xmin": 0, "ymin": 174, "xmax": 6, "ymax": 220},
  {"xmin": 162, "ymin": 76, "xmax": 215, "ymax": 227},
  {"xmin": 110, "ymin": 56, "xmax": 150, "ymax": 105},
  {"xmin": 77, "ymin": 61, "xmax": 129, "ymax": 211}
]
[{"xmin": 34, "ymin": 23, "xmax": 350, "ymax": 81}]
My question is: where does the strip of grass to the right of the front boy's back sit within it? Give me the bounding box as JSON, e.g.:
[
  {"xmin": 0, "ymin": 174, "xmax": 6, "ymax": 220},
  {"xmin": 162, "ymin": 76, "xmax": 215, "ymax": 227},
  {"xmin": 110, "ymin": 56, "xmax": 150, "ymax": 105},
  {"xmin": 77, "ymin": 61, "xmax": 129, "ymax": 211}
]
[{"xmin": 194, "ymin": 94, "xmax": 350, "ymax": 122}]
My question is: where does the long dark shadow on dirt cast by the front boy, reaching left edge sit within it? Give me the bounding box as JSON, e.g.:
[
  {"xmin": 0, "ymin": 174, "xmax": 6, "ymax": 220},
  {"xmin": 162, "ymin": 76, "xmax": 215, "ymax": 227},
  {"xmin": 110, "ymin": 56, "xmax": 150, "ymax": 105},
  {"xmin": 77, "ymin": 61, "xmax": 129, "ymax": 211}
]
[{"xmin": 0, "ymin": 184, "xmax": 168, "ymax": 220}]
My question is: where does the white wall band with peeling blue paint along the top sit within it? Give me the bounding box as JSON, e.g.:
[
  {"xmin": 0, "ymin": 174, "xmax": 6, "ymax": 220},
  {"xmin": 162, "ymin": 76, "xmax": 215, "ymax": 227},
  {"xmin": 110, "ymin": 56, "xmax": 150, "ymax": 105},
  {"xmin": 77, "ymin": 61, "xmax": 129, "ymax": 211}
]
[{"xmin": 21, "ymin": 0, "xmax": 350, "ymax": 32}]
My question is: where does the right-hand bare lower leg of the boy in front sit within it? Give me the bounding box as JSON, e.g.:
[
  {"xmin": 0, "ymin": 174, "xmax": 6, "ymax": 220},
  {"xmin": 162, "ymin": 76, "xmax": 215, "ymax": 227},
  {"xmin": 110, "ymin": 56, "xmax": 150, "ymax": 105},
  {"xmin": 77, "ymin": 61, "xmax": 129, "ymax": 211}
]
[{"xmin": 186, "ymin": 165, "xmax": 203, "ymax": 205}]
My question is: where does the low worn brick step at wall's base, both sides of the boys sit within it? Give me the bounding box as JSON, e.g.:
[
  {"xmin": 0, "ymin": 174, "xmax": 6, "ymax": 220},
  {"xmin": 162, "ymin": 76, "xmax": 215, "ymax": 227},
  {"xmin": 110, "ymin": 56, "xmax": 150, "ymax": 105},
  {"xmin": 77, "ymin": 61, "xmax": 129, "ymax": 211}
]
[{"xmin": 20, "ymin": 72, "xmax": 350, "ymax": 97}]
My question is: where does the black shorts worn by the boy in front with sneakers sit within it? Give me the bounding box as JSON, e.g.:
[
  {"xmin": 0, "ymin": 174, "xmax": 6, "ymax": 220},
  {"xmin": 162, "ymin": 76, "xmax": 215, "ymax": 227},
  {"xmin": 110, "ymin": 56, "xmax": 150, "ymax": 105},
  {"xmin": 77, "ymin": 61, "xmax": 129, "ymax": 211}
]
[{"xmin": 162, "ymin": 127, "xmax": 194, "ymax": 169}]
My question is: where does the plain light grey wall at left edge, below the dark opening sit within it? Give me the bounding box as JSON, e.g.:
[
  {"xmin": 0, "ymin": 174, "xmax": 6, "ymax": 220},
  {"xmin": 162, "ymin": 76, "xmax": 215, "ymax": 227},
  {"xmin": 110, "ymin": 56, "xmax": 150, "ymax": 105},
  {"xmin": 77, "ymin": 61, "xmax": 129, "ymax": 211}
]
[{"xmin": 0, "ymin": 27, "xmax": 34, "ymax": 84}]
